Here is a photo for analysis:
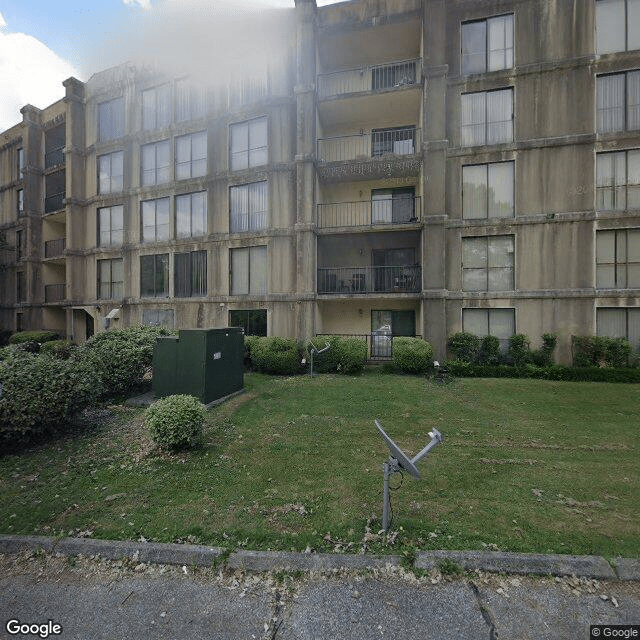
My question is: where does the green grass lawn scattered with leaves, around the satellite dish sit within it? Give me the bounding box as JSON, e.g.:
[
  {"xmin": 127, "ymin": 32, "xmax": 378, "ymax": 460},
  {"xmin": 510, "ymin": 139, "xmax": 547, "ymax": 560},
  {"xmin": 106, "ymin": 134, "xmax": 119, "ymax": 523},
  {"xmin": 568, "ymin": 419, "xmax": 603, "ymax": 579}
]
[{"xmin": 0, "ymin": 372, "xmax": 640, "ymax": 558}]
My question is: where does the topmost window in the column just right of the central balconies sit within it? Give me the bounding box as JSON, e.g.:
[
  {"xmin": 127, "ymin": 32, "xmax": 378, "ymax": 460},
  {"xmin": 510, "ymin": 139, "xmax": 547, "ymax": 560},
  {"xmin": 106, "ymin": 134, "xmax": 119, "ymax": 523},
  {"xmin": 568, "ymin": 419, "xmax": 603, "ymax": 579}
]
[{"xmin": 461, "ymin": 14, "xmax": 513, "ymax": 76}]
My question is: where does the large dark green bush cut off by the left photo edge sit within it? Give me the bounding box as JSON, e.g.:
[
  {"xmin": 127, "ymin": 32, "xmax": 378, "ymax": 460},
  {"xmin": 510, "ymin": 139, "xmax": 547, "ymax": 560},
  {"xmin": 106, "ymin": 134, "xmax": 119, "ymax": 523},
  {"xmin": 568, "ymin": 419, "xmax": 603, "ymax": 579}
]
[{"xmin": 0, "ymin": 351, "xmax": 100, "ymax": 444}]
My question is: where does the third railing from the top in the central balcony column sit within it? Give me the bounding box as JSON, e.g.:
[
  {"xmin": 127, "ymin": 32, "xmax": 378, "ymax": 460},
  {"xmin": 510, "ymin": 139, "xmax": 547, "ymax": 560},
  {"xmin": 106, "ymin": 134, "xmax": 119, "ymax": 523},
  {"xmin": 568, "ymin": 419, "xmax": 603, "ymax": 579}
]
[{"xmin": 318, "ymin": 196, "xmax": 420, "ymax": 229}]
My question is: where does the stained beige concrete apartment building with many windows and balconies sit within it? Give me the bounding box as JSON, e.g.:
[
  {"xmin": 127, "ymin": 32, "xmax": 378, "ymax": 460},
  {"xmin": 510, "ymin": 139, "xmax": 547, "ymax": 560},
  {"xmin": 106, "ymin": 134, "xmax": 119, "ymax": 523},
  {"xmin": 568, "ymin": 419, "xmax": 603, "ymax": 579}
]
[{"xmin": 0, "ymin": 0, "xmax": 640, "ymax": 362}]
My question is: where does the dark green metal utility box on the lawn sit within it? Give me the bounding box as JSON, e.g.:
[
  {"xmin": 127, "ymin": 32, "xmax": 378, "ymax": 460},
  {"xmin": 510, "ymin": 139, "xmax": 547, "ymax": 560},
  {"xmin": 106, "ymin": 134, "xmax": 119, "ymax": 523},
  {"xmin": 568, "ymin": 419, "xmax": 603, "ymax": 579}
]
[{"xmin": 153, "ymin": 327, "xmax": 244, "ymax": 404}]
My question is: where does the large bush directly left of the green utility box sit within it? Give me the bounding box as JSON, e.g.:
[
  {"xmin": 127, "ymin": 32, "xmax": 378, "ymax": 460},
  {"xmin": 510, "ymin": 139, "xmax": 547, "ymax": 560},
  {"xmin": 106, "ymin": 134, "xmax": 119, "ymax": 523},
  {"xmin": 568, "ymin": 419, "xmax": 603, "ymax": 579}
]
[{"xmin": 78, "ymin": 326, "xmax": 170, "ymax": 398}]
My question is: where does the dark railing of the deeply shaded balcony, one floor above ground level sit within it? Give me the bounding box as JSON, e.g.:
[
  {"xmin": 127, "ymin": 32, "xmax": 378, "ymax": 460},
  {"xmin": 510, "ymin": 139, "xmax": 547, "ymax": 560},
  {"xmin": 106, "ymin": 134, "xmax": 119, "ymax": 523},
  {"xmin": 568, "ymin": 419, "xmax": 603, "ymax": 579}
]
[{"xmin": 318, "ymin": 265, "xmax": 422, "ymax": 295}]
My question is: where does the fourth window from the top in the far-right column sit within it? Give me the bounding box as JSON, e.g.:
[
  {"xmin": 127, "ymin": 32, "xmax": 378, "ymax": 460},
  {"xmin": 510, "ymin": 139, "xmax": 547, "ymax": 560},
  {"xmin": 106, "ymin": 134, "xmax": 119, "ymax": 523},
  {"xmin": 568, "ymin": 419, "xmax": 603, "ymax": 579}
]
[{"xmin": 596, "ymin": 228, "xmax": 640, "ymax": 289}]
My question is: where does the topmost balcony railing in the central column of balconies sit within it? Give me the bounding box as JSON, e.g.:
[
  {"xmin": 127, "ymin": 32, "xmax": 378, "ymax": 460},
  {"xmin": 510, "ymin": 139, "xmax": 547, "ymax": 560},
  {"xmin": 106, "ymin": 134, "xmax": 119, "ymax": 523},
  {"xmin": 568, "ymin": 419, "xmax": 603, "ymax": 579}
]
[{"xmin": 318, "ymin": 58, "xmax": 422, "ymax": 98}]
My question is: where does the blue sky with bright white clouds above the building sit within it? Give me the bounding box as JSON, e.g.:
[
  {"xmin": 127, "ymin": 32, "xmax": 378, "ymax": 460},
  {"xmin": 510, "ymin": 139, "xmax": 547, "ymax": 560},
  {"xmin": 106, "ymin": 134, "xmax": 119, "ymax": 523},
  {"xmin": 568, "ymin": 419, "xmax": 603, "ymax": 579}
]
[{"xmin": 0, "ymin": 0, "xmax": 338, "ymax": 131}]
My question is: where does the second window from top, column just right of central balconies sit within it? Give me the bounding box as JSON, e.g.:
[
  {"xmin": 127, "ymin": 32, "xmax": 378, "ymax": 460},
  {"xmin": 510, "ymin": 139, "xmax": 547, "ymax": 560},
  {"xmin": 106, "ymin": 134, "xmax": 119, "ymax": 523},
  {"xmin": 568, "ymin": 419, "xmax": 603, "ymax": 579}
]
[{"xmin": 462, "ymin": 89, "xmax": 513, "ymax": 147}]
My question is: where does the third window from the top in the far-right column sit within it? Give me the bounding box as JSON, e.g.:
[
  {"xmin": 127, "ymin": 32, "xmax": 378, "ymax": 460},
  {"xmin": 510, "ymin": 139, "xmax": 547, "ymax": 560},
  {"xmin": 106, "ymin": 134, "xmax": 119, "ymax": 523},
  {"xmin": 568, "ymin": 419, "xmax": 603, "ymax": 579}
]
[{"xmin": 596, "ymin": 149, "xmax": 640, "ymax": 211}]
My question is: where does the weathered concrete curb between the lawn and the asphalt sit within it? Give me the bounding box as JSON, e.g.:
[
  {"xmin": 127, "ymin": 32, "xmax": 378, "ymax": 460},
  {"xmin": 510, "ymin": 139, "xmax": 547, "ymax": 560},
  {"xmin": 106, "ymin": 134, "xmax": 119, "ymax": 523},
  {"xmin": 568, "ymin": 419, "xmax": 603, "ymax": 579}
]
[{"xmin": 0, "ymin": 535, "xmax": 640, "ymax": 581}]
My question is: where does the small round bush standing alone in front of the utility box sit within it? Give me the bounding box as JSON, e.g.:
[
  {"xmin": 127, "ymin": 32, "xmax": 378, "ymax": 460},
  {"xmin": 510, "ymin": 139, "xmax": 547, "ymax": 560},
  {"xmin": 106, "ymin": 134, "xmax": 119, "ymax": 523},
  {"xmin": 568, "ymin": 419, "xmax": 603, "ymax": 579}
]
[{"xmin": 144, "ymin": 395, "xmax": 206, "ymax": 450}]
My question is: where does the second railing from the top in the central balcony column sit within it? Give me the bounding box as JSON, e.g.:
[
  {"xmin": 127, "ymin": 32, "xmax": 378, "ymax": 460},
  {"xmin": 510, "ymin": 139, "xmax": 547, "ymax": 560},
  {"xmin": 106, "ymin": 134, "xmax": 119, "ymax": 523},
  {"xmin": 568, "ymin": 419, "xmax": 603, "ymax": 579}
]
[{"xmin": 317, "ymin": 127, "xmax": 420, "ymax": 162}]
